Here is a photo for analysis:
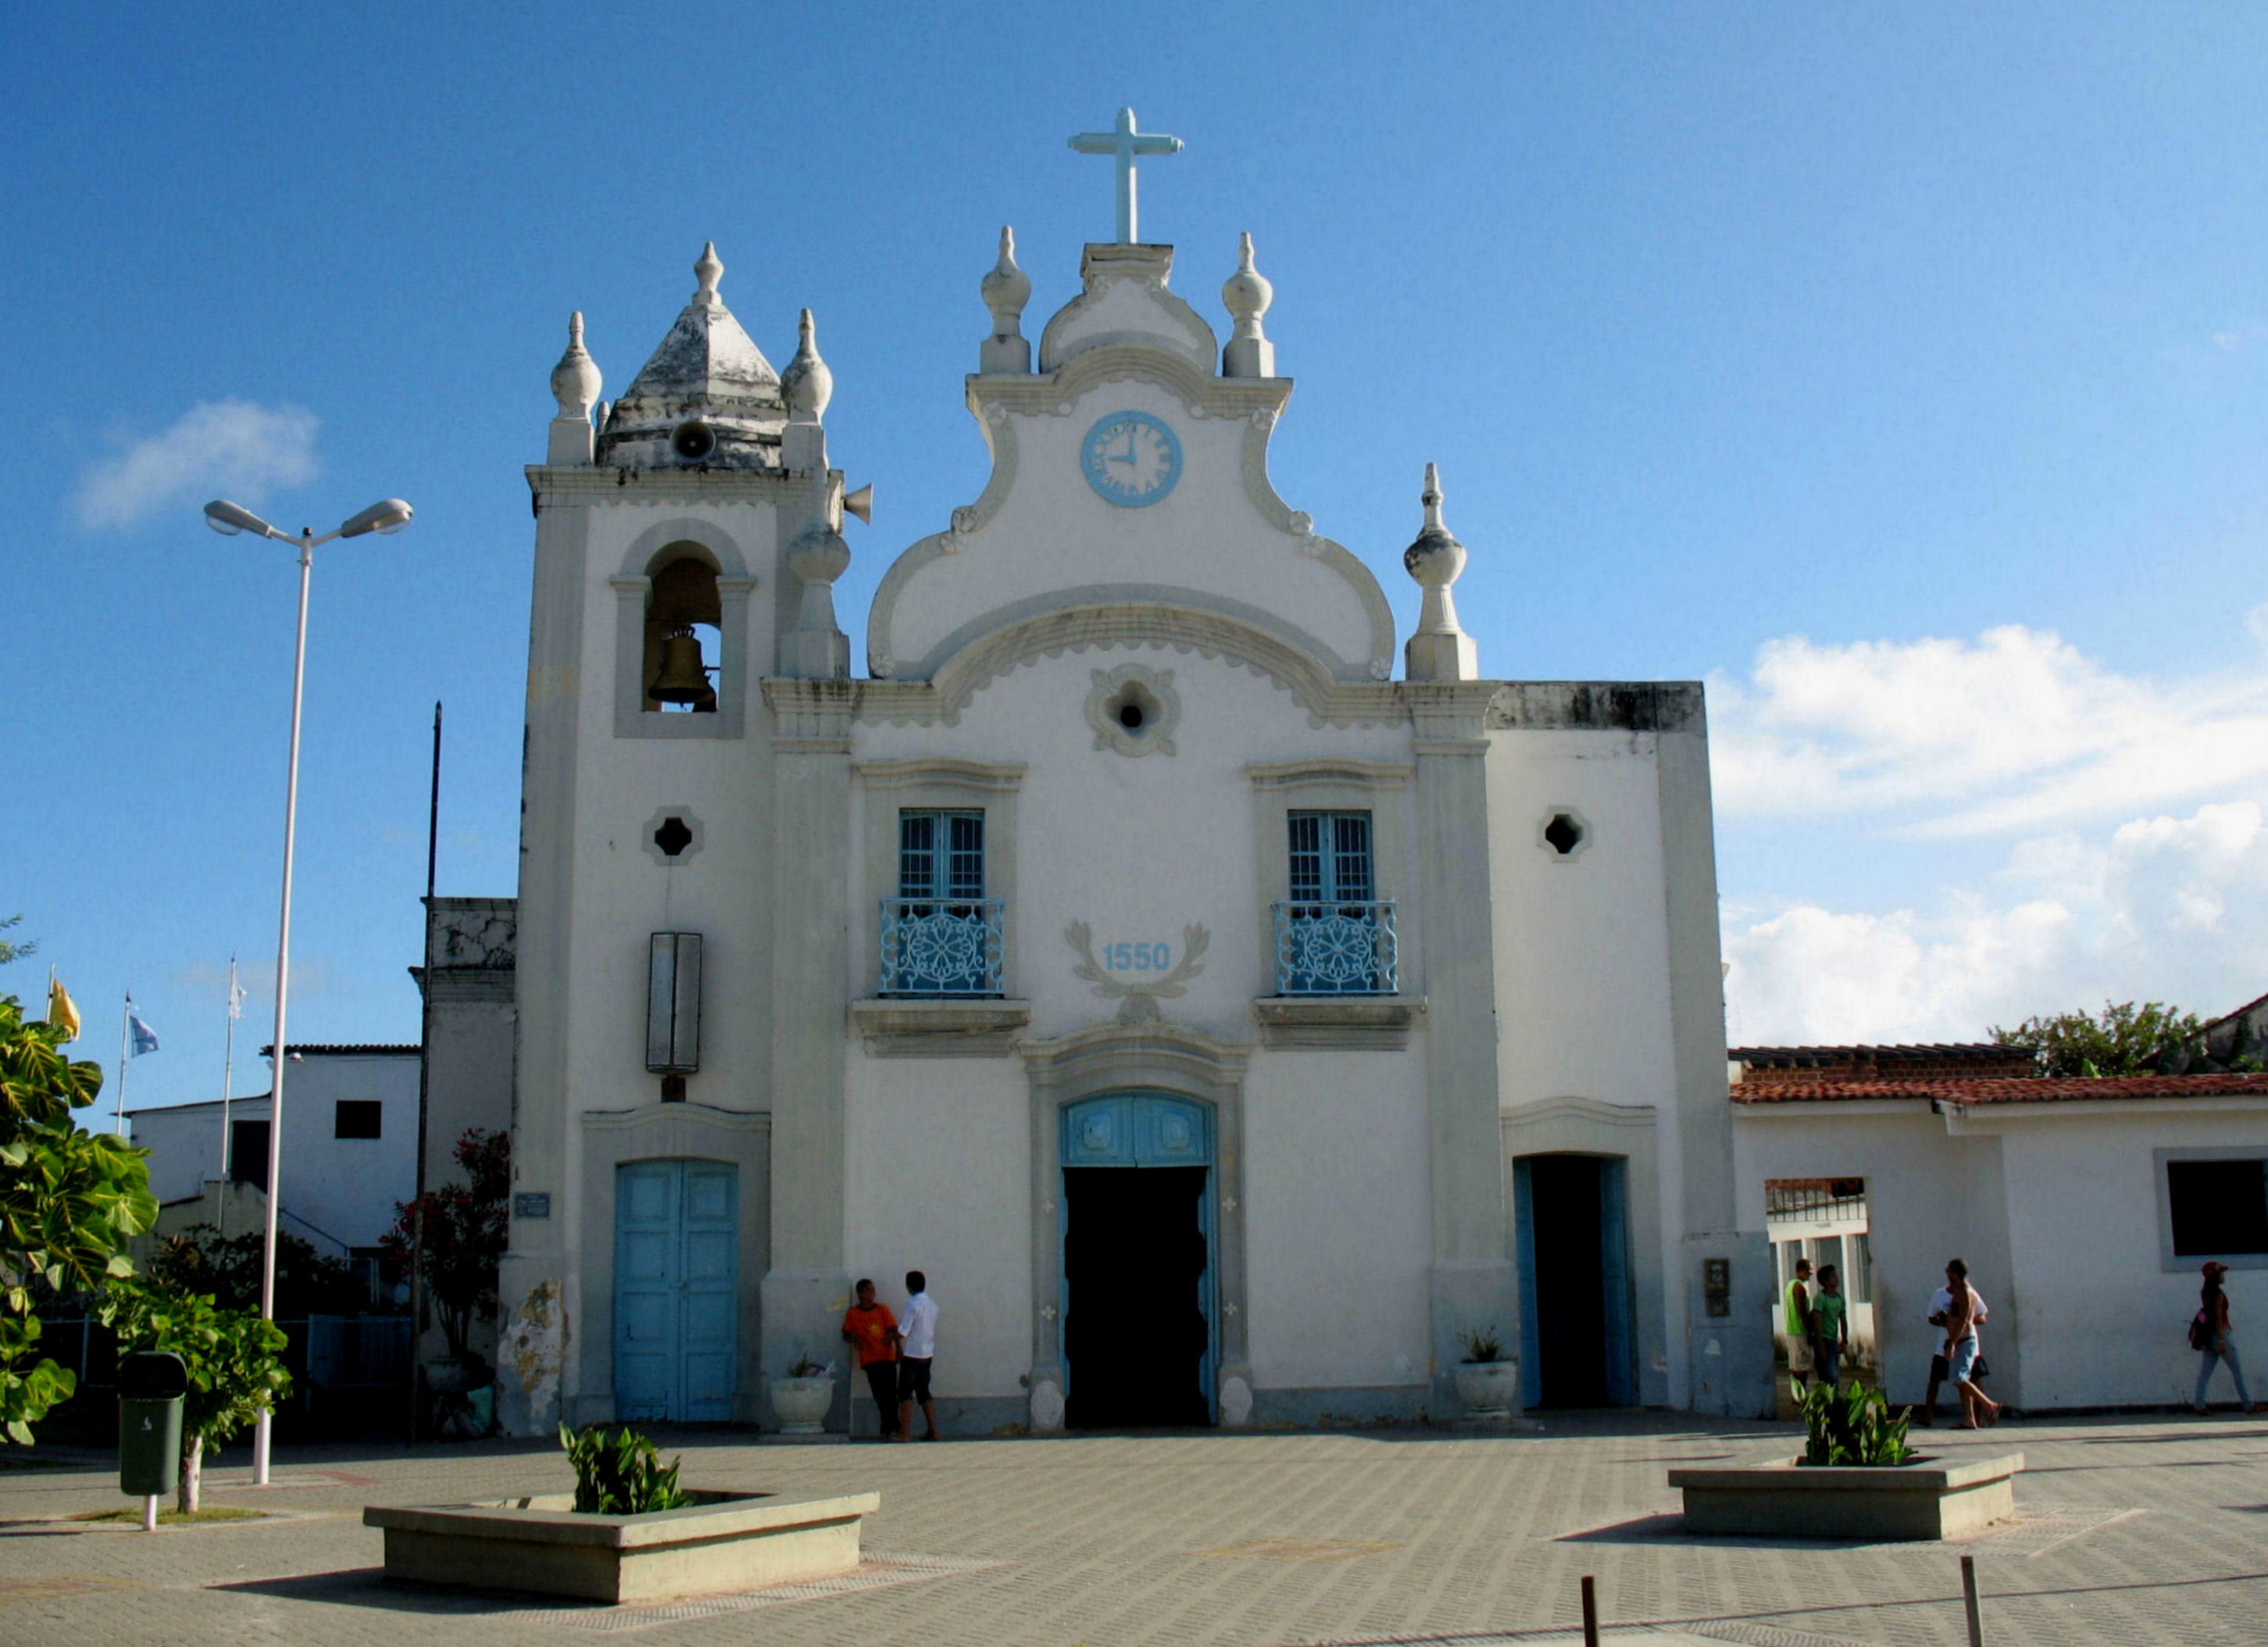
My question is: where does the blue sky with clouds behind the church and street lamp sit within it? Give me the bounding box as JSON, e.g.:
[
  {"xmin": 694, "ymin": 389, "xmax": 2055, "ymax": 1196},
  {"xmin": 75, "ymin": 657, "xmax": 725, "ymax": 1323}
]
[{"xmin": 0, "ymin": 2, "xmax": 2268, "ymax": 1100}]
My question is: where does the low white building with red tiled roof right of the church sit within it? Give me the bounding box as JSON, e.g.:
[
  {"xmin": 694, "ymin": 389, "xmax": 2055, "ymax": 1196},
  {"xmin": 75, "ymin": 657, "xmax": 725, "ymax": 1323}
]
[{"xmin": 1733, "ymin": 1066, "xmax": 2268, "ymax": 1411}]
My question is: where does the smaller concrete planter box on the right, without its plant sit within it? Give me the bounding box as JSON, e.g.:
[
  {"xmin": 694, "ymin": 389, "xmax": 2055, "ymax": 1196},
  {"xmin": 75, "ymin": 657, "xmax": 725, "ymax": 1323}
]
[{"xmin": 1670, "ymin": 1452, "xmax": 2023, "ymax": 1538}]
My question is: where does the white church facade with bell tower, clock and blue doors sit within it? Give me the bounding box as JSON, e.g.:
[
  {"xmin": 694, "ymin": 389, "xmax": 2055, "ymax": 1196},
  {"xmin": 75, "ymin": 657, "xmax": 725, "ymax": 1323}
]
[{"xmin": 499, "ymin": 164, "xmax": 1771, "ymax": 1434}]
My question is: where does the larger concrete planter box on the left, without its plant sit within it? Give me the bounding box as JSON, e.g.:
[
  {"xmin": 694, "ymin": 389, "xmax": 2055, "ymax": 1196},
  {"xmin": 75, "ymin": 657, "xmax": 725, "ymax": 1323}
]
[{"xmin": 363, "ymin": 1491, "xmax": 882, "ymax": 1602}]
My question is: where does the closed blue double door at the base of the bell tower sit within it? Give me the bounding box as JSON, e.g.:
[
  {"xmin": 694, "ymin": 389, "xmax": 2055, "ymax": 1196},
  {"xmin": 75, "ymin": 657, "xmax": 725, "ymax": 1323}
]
[{"xmin": 615, "ymin": 1162, "xmax": 739, "ymax": 1423}]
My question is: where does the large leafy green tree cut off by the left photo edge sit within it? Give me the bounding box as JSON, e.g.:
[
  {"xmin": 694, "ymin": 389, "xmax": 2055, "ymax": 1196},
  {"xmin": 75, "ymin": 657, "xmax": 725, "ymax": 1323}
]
[{"xmin": 0, "ymin": 996, "xmax": 156, "ymax": 1445}]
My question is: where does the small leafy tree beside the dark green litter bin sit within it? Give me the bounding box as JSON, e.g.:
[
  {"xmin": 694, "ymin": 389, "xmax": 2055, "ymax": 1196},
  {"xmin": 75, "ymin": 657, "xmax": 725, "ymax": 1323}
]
[{"xmin": 102, "ymin": 1280, "xmax": 291, "ymax": 1516}]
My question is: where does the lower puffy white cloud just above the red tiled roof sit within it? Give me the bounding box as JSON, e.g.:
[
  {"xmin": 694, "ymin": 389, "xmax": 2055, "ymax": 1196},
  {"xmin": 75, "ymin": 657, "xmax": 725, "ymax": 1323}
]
[{"xmin": 1723, "ymin": 801, "xmax": 2268, "ymax": 1046}]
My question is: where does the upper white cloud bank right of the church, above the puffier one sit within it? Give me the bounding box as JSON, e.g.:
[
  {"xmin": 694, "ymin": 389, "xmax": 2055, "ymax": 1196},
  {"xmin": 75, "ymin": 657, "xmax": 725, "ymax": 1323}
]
[{"xmin": 1710, "ymin": 608, "xmax": 2268, "ymax": 835}]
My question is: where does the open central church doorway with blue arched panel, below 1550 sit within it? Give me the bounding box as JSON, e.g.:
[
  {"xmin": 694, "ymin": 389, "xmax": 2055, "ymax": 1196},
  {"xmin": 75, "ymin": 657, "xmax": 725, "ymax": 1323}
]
[{"xmin": 1059, "ymin": 1091, "xmax": 1220, "ymax": 1429}]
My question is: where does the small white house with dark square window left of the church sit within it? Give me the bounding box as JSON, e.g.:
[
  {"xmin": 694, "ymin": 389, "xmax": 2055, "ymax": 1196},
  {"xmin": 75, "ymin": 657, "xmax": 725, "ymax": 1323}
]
[{"xmin": 127, "ymin": 1046, "xmax": 421, "ymax": 1259}]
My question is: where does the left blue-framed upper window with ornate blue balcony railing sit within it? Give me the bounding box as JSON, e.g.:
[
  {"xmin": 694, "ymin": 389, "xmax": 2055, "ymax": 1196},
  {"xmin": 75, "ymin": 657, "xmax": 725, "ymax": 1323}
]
[{"xmin": 880, "ymin": 810, "xmax": 1002, "ymax": 996}]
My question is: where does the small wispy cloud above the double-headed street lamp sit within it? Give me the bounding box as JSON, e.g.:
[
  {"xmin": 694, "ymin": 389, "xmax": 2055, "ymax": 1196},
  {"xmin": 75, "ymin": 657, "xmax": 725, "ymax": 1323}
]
[{"xmin": 75, "ymin": 399, "xmax": 322, "ymax": 529}]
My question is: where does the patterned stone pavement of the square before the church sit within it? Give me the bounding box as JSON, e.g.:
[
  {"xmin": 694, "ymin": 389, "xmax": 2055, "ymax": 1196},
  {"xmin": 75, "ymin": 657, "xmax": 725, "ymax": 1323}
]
[{"xmin": 0, "ymin": 1413, "xmax": 2268, "ymax": 1647}]
